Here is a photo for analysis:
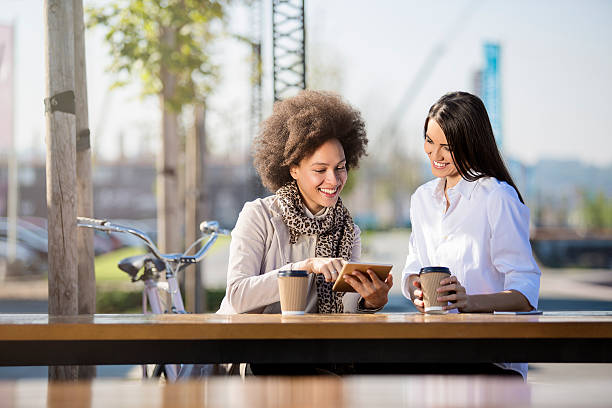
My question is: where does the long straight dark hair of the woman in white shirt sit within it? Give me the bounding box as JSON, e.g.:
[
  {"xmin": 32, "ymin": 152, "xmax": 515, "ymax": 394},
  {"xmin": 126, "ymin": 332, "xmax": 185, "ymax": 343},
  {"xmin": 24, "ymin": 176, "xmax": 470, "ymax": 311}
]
[{"xmin": 423, "ymin": 92, "xmax": 525, "ymax": 203}]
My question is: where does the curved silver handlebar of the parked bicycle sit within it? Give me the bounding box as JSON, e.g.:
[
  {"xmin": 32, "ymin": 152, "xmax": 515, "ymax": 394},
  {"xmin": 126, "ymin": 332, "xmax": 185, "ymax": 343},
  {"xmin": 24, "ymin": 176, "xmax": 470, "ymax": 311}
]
[{"xmin": 77, "ymin": 217, "xmax": 230, "ymax": 264}]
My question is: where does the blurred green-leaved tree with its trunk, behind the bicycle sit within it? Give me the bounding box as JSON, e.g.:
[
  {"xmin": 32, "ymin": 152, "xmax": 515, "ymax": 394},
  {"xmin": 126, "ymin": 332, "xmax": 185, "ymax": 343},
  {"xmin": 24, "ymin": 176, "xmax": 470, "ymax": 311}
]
[{"xmin": 87, "ymin": 0, "xmax": 230, "ymax": 251}]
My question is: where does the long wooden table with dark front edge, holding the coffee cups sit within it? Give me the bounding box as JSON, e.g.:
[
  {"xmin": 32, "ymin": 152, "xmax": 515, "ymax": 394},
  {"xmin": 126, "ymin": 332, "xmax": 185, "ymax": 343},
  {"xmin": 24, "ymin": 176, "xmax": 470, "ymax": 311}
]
[{"xmin": 0, "ymin": 312, "xmax": 612, "ymax": 366}]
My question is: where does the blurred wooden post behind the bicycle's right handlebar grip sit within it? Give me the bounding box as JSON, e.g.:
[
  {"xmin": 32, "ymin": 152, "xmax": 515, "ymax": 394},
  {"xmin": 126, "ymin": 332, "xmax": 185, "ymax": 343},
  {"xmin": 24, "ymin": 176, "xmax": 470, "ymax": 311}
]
[{"xmin": 184, "ymin": 104, "xmax": 206, "ymax": 313}]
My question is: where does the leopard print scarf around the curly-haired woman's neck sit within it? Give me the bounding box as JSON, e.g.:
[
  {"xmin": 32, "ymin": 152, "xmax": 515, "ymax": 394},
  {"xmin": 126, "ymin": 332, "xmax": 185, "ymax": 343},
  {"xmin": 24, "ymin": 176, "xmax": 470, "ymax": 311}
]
[{"xmin": 276, "ymin": 180, "xmax": 355, "ymax": 313}]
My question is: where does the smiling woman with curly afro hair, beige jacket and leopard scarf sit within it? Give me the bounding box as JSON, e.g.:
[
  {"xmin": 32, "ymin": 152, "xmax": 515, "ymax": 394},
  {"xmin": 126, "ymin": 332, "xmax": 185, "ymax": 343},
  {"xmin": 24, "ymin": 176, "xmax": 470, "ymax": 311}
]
[{"xmin": 218, "ymin": 91, "xmax": 393, "ymax": 314}]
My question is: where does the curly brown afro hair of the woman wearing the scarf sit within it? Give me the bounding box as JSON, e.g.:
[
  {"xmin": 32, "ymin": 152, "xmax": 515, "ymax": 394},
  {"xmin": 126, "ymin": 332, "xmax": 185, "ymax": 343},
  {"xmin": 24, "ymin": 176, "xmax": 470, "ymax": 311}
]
[{"xmin": 253, "ymin": 90, "xmax": 368, "ymax": 192}]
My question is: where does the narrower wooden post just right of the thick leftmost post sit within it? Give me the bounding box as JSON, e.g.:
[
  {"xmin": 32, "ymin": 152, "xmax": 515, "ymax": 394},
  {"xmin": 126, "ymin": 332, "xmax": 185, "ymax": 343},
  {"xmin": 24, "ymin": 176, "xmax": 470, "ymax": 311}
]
[{"xmin": 73, "ymin": 0, "xmax": 96, "ymax": 380}]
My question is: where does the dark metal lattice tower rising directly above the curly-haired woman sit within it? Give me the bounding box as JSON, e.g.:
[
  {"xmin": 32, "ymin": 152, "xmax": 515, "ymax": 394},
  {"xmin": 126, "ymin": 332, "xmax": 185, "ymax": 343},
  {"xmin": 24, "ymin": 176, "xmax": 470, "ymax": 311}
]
[{"xmin": 272, "ymin": 0, "xmax": 306, "ymax": 101}]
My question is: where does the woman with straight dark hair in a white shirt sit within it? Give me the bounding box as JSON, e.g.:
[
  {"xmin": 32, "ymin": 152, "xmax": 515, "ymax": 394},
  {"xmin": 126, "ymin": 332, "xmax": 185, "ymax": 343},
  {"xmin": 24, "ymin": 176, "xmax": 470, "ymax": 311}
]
[{"xmin": 402, "ymin": 92, "xmax": 540, "ymax": 377}]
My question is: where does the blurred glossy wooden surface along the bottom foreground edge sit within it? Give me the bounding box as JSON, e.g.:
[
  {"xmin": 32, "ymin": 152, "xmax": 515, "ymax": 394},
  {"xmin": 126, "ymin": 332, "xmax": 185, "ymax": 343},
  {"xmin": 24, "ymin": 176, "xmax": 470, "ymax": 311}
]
[{"xmin": 0, "ymin": 376, "xmax": 610, "ymax": 408}]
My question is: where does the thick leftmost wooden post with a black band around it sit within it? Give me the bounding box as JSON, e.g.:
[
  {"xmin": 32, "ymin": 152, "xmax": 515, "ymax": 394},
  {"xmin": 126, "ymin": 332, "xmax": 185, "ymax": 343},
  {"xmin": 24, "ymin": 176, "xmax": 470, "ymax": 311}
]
[{"xmin": 44, "ymin": 0, "xmax": 78, "ymax": 380}]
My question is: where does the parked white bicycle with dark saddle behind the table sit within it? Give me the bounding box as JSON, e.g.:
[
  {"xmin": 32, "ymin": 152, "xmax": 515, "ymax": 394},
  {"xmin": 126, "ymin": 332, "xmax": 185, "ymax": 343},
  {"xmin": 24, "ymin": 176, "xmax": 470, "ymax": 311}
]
[{"xmin": 77, "ymin": 217, "xmax": 230, "ymax": 382}]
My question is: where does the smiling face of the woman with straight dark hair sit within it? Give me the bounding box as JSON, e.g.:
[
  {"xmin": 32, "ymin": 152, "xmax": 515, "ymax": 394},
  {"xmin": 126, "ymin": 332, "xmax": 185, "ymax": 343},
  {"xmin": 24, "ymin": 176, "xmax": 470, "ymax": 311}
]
[{"xmin": 425, "ymin": 118, "xmax": 461, "ymax": 188}]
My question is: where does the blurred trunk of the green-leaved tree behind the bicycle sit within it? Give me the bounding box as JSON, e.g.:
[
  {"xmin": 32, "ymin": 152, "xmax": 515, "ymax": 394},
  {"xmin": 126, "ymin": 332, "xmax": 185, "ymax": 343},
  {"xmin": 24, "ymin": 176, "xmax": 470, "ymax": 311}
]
[{"xmin": 157, "ymin": 27, "xmax": 181, "ymax": 252}]
